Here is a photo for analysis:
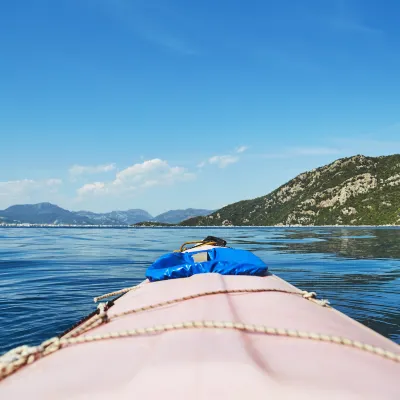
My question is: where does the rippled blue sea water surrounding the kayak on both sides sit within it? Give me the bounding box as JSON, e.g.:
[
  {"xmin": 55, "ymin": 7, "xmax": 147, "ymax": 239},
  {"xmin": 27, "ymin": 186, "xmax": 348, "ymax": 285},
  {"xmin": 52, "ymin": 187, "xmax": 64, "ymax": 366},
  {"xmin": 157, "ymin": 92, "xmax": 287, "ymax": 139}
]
[{"xmin": 0, "ymin": 228, "xmax": 400, "ymax": 354}]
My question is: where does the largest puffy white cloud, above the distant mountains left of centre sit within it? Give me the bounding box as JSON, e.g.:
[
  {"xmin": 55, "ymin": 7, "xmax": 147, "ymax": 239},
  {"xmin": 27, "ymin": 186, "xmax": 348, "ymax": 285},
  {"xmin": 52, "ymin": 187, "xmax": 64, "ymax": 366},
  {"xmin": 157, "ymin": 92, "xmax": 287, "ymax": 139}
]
[{"xmin": 77, "ymin": 158, "xmax": 195, "ymax": 197}]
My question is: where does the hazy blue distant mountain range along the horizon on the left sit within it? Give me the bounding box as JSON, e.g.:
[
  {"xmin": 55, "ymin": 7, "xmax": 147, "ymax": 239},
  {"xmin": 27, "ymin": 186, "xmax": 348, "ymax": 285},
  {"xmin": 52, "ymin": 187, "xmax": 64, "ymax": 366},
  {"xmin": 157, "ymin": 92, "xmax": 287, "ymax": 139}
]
[{"xmin": 0, "ymin": 202, "xmax": 216, "ymax": 226}]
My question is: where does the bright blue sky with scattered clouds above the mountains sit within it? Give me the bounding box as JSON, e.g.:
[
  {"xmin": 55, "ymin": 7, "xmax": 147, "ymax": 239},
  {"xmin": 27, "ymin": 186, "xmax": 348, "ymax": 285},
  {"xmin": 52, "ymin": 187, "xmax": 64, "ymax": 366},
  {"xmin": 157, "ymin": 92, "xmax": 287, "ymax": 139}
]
[{"xmin": 0, "ymin": 0, "xmax": 400, "ymax": 214}]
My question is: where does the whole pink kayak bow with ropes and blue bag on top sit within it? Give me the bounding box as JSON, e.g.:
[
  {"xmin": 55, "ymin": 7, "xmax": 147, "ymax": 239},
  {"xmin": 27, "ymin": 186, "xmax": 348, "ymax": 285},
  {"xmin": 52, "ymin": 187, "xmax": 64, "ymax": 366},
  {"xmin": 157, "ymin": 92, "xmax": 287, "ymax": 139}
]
[{"xmin": 0, "ymin": 237, "xmax": 400, "ymax": 400}]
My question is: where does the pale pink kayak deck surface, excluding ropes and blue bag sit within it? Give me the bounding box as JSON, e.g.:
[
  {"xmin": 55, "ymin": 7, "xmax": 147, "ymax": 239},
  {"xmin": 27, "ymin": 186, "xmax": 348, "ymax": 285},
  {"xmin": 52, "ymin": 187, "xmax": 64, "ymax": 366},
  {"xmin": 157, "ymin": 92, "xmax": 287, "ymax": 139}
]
[{"xmin": 0, "ymin": 247, "xmax": 400, "ymax": 400}]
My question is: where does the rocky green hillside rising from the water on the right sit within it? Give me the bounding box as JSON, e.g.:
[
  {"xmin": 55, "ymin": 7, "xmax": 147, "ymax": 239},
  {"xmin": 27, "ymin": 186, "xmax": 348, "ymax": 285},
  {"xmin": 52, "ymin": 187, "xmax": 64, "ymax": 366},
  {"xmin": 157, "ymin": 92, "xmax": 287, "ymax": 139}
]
[{"xmin": 181, "ymin": 154, "xmax": 400, "ymax": 226}]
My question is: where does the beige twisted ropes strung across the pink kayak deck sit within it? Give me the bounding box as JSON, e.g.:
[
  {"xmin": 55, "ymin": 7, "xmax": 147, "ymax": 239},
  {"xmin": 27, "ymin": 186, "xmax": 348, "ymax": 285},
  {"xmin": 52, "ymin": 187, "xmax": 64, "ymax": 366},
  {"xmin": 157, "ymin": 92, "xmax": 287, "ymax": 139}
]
[{"xmin": 0, "ymin": 283, "xmax": 400, "ymax": 380}]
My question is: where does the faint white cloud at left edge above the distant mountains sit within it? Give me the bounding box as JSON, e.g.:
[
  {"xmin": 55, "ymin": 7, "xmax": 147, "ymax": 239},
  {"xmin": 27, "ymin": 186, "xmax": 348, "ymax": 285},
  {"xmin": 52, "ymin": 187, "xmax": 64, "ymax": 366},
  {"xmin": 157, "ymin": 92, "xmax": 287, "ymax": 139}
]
[{"xmin": 0, "ymin": 178, "xmax": 62, "ymax": 208}]
